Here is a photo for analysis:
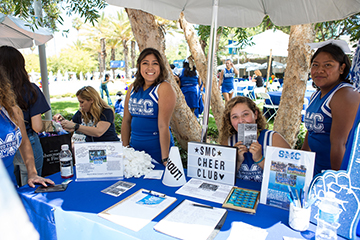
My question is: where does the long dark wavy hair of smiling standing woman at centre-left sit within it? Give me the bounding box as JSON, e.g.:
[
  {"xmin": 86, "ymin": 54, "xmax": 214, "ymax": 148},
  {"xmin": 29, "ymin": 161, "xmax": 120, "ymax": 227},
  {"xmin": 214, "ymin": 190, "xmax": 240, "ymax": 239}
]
[{"xmin": 133, "ymin": 48, "xmax": 168, "ymax": 92}]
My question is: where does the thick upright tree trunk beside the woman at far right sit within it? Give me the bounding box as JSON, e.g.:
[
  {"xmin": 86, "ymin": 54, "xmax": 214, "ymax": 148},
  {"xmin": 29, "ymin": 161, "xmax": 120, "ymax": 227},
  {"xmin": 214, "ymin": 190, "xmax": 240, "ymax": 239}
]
[{"xmin": 274, "ymin": 24, "xmax": 315, "ymax": 147}]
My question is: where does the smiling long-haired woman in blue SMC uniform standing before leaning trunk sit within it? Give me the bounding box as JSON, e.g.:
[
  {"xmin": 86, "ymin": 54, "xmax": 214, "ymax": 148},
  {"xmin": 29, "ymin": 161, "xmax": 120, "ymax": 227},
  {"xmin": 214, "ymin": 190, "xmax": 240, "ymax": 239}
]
[{"xmin": 121, "ymin": 48, "xmax": 176, "ymax": 165}]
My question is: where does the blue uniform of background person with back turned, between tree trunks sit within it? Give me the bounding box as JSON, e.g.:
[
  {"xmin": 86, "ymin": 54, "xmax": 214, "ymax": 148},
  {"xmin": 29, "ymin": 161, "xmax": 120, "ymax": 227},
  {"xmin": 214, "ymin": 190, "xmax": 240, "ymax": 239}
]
[{"xmin": 179, "ymin": 69, "xmax": 200, "ymax": 108}]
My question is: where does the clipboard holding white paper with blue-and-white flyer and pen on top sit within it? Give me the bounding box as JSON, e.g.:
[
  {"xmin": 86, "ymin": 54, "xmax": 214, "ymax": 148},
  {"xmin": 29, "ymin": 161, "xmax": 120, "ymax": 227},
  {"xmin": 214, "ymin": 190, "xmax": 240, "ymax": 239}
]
[{"xmin": 98, "ymin": 189, "xmax": 176, "ymax": 232}]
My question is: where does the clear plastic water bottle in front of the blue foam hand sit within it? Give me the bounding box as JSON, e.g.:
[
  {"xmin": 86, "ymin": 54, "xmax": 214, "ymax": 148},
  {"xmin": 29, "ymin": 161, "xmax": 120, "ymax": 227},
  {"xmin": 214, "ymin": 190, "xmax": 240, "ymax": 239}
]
[{"xmin": 315, "ymin": 192, "xmax": 340, "ymax": 240}]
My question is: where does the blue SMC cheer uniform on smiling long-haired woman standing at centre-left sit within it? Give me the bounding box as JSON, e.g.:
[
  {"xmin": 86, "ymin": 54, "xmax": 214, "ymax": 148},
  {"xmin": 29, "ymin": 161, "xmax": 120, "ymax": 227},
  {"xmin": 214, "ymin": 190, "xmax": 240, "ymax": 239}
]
[{"xmin": 128, "ymin": 83, "xmax": 174, "ymax": 163}]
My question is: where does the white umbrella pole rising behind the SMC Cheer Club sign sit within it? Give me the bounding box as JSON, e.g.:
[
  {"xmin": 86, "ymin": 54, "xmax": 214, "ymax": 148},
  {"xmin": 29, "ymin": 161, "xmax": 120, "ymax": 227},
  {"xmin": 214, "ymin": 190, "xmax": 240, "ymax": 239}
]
[{"xmin": 201, "ymin": 0, "xmax": 219, "ymax": 143}]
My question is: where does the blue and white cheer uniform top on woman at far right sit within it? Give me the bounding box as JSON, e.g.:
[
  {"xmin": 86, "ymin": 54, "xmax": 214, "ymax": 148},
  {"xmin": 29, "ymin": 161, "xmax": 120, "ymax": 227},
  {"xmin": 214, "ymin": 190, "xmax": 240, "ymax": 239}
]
[{"xmin": 305, "ymin": 82, "xmax": 353, "ymax": 176}]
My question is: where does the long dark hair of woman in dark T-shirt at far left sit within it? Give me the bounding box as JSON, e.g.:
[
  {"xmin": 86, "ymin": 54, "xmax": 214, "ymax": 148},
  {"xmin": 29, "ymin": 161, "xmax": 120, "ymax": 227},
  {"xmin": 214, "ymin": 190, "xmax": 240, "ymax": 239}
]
[{"xmin": 0, "ymin": 46, "xmax": 38, "ymax": 111}]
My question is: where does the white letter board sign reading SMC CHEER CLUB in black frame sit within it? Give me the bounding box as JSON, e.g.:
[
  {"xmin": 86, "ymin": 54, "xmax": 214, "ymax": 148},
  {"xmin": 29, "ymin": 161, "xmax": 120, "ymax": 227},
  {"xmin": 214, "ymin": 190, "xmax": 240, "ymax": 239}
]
[{"xmin": 187, "ymin": 142, "xmax": 236, "ymax": 185}]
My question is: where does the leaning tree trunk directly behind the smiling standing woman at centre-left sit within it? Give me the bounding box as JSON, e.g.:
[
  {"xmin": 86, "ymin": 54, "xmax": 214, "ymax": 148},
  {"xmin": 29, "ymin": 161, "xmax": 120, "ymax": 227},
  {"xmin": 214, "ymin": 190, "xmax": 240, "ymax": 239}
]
[{"xmin": 125, "ymin": 8, "xmax": 201, "ymax": 149}]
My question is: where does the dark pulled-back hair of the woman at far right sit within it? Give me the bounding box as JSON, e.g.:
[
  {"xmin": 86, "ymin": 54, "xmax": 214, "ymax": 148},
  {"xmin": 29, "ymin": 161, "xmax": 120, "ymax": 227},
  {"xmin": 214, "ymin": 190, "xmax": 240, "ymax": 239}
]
[{"xmin": 310, "ymin": 43, "xmax": 351, "ymax": 90}]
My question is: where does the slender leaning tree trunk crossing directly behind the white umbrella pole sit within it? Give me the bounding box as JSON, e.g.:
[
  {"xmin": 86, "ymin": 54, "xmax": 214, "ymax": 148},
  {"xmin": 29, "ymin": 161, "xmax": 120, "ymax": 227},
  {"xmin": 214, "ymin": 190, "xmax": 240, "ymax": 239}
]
[{"xmin": 179, "ymin": 13, "xmax": 225, "ymax": 129}]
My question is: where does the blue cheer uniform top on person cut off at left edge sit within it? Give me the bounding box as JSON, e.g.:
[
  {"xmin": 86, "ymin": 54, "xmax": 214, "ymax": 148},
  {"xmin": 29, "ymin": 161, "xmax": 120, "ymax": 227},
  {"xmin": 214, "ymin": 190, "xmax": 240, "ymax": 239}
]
[{"xmin": 0, "ymin": 107, "xmax": 22, "ymax": 186}]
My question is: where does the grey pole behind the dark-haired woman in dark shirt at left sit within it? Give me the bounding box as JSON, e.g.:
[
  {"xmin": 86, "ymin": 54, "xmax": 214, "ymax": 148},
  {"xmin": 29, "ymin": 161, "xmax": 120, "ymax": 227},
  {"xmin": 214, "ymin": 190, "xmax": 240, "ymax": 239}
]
[{"xmin": 34, "ymin": 0, "xmax": 52, "ymax": 120}]
